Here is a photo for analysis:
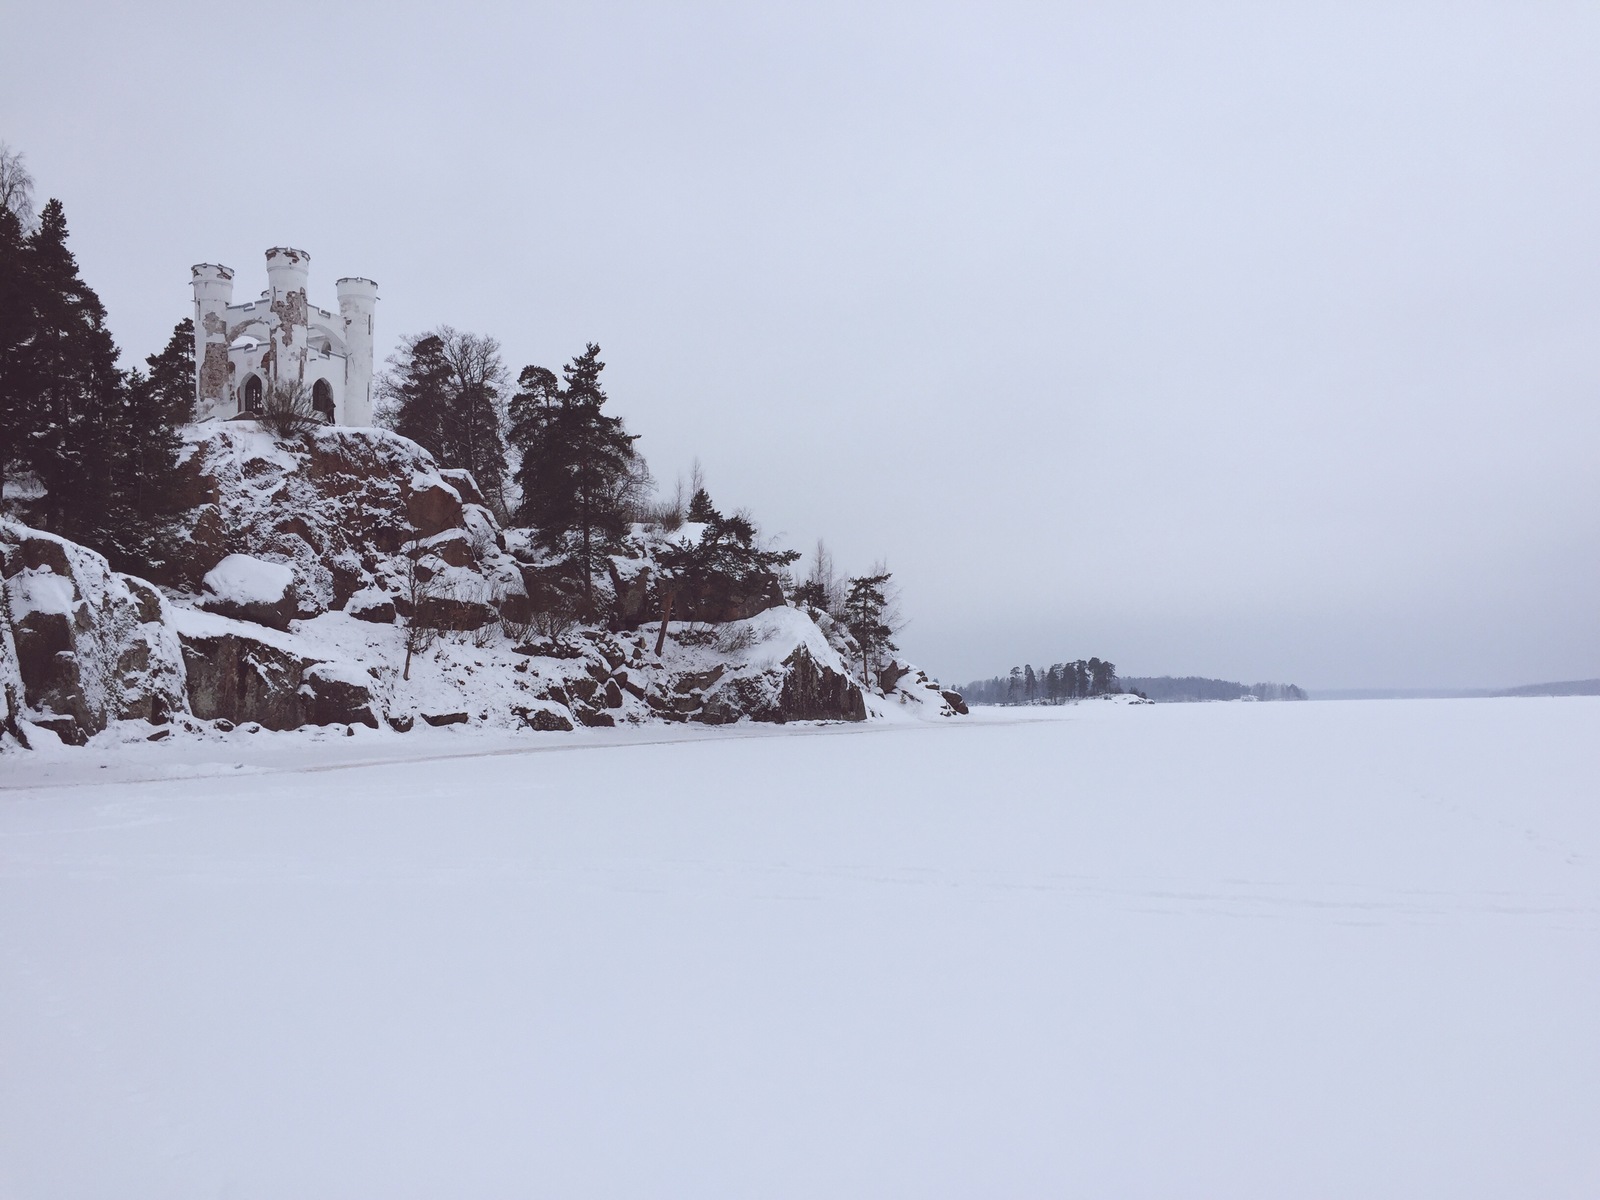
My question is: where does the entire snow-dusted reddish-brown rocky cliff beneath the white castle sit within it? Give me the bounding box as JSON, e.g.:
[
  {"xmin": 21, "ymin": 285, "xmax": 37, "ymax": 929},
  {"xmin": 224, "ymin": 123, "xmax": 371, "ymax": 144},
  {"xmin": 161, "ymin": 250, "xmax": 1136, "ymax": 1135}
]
[{"xmin": 0, "ymin": 422, "xmax": 958, "ymax": 742}]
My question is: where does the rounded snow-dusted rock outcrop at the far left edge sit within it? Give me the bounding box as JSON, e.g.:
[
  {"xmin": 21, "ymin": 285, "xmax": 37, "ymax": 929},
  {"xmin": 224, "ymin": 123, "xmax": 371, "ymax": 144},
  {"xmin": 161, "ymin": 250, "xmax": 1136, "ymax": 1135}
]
[{"xmin": 0, "ymin": 522, "xmax": 187, "ymax": 742}]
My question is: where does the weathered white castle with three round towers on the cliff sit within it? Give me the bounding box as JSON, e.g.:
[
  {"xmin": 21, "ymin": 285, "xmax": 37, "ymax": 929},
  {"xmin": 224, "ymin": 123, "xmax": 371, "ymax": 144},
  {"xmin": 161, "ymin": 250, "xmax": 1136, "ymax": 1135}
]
[{"xmin": 189, "ymin": 246, "xmax": 378, "ymax": 426}]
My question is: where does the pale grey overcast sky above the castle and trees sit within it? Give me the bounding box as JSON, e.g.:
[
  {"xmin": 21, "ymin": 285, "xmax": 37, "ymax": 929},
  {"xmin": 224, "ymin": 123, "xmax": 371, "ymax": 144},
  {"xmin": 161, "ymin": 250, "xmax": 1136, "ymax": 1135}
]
[{"xmin": 0, "ymin": 0, "xmax": 1600, "ymax": 688}]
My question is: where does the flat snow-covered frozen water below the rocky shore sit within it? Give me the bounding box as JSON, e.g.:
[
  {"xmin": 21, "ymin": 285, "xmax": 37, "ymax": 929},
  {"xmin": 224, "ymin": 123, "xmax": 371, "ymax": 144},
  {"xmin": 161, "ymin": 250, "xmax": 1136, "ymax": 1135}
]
[{"xmin": 0, "ymin": 698, "xmax": 1600, "ymax": 1200}]
